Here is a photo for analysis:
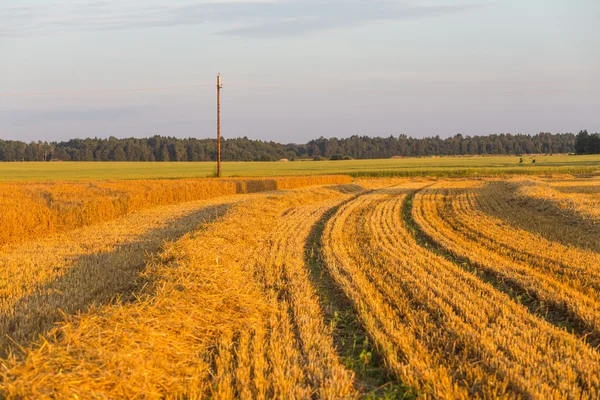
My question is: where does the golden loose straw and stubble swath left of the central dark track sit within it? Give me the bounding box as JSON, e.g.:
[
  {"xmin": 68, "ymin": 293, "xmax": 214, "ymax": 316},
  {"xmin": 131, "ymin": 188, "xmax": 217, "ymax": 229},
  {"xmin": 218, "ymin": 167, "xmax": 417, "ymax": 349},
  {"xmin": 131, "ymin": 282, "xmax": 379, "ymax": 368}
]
[{"xmin": 1, "ymin": 188, "xmax": 366, "ymax": 398}]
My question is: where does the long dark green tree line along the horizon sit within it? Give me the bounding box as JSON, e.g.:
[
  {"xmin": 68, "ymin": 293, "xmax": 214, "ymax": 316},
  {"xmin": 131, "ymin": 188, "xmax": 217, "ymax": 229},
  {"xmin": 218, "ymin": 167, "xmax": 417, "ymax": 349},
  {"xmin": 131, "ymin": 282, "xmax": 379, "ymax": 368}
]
[{"xmin": 0, "ymin": 131, "xmax": 600, "ymax": 161}]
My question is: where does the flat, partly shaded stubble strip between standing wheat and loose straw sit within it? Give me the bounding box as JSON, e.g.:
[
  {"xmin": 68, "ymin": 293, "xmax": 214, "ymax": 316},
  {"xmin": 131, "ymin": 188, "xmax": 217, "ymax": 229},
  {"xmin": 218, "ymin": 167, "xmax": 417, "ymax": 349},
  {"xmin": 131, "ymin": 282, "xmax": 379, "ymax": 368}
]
[{"xmin": 0, "ymin": 195, "xmax": 252, "ymax": 356}]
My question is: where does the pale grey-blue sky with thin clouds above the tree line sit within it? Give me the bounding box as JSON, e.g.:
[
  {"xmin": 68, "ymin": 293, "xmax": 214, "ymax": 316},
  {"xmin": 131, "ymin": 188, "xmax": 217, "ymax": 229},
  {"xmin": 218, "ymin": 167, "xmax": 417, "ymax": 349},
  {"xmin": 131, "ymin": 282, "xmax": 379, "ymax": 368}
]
[{"xmin": 0, "ymin": 0, "xmax": 600, "ymax": 143}]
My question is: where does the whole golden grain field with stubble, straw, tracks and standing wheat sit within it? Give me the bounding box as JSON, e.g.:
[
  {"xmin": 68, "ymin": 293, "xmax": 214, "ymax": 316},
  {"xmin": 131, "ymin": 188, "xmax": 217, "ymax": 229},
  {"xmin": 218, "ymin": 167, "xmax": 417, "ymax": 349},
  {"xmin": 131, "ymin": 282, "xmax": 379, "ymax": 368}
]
[{"xmin": 0, "ymin": 171, "xmax": 600, "ymax": 399}]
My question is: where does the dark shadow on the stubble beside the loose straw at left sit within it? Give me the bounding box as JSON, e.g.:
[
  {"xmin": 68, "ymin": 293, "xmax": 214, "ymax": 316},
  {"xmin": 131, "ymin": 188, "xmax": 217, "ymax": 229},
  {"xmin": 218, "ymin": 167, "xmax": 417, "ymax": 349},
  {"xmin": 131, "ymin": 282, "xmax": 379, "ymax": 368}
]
[{"xmin": 0, "ymin": 204, "xmax": 231, "ymax": 357}]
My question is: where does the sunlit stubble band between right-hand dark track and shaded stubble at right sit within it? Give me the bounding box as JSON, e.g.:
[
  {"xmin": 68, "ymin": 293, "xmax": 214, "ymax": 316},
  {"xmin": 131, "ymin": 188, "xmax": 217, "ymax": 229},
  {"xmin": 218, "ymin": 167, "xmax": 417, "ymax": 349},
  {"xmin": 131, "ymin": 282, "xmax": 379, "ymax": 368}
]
[{"xmin": 412, "ymin": 182, "xmax": 600, "ymax": 343}]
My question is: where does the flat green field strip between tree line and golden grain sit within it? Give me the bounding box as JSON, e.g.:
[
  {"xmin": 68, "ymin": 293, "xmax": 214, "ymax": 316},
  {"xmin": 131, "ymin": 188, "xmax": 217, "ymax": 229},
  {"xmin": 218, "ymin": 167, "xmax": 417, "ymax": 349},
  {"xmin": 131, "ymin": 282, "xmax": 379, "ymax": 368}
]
[{"xmin": 0, "ymin": 155, "xmax": 600, "ymax": 181}]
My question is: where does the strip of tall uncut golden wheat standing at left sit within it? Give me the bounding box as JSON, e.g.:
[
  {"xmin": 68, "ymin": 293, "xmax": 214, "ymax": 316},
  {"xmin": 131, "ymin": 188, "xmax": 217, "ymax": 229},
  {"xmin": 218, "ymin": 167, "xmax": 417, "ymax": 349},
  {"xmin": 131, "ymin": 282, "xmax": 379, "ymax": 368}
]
[{"xmin": 0, "ymin": 175, "xmax": 351, "ymax": 247}]
